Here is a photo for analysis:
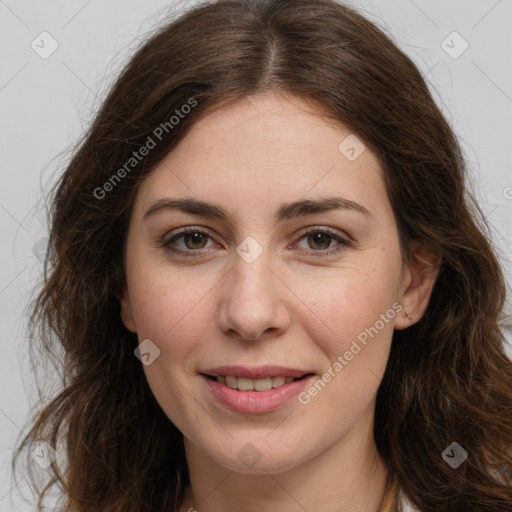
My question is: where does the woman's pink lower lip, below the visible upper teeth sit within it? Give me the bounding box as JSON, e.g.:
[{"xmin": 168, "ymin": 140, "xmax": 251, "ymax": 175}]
[{"xmin": 201, "ymin": 375, "xmax": 314, "ymax": 414}]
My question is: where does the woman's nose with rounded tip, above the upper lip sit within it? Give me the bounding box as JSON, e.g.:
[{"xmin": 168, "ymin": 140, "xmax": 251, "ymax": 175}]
[{"xmin": 217, "ymin": 242, "xmax": 291, "ymax": 341}]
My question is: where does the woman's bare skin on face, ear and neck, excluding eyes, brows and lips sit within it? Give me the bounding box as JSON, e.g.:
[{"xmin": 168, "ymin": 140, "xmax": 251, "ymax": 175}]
[{"xmin": 121, "ymin": 94, "xmax": 436, "ymax": 512}]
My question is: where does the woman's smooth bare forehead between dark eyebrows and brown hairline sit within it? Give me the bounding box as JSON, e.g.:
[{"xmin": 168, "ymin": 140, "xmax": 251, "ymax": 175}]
[{"xmin": 134, "ymin": 95, "xmax": 389, "ymax": 222}]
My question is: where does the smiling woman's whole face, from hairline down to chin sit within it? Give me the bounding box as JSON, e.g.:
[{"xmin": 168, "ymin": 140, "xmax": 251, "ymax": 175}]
[{"xmin": 122, "ymin": 95, "xmax": 420, "ymax": 473}]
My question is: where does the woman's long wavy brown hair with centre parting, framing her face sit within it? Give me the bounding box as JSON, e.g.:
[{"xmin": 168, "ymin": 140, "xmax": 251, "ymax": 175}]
[{"xmin": 14, "ymin": 0, "xmax": 512, "ymax": 512}]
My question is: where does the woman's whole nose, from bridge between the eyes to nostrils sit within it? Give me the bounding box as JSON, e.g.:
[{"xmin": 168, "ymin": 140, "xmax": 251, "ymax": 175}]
[{"xmin": 219, "ymin": 235, "xmax": 288, "ymax": 340}]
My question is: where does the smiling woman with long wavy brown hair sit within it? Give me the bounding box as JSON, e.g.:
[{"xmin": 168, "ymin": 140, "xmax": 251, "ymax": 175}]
[{"xmin": 12, "ymin": 0, "xmax": 512, "ymax": 512}]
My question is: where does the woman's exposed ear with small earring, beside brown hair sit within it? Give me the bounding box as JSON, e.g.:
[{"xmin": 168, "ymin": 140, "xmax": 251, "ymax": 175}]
[{"xmin": 395, "ymin": 241, "xmax": 441, "ymax": 329}]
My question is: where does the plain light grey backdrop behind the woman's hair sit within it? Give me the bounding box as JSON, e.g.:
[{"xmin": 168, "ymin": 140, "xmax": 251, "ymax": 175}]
[{"xmin": 0, "ymin": 0, "xmax": 512, "ymax": 512}]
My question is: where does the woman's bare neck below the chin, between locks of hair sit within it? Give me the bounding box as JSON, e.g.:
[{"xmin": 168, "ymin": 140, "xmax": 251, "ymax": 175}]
[{"xmin": 180, "ymin": 412, "xmax": 391, "ymax": 512}]
